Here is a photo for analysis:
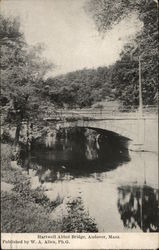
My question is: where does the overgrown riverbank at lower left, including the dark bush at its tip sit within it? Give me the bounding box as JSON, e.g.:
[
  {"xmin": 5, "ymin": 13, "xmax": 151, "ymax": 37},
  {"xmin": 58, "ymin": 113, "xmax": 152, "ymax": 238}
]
[{"xmin": 1, "ymin": 144, "xmax": 98, "ymax": 233}]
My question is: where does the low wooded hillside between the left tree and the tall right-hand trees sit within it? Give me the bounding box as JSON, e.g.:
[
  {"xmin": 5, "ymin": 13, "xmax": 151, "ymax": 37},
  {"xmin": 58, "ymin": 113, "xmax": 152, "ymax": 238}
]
[{"xmin": 46, "ymin": 67, "xmax": 114, "ymax": 107}]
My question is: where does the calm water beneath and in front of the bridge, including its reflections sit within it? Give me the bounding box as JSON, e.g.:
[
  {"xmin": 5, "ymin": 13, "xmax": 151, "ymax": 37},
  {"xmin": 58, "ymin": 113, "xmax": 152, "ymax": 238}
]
[{"xmin": 20, "ymin": 130, "xmax": 158, "ymax": 232}]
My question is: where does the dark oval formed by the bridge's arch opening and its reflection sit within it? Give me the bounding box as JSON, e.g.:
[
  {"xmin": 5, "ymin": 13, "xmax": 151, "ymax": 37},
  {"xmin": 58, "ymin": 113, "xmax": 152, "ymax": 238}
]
[{"xmin": 21, "ymin": 128, "xmax": 130, "ymax": 181}]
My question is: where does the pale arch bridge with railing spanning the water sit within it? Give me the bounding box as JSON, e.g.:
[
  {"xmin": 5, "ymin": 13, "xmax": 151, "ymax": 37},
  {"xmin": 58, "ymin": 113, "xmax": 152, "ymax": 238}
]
[{"xmin": 45, "ymin": 108, "xmax": 158, "ymax": 151}]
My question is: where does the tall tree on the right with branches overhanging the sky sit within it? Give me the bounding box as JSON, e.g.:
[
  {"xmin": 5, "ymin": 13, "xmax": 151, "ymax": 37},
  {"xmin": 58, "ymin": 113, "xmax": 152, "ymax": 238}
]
[{"xmin": 86, "ymin": 0, "xmax": 158, "ymax": 105}]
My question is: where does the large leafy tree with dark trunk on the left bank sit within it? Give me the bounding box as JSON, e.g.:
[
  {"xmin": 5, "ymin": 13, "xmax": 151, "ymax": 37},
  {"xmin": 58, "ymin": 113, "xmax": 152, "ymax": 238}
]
[{"xmin": 0, "ymin": 15, "xmax": 52, "ymax": 144}]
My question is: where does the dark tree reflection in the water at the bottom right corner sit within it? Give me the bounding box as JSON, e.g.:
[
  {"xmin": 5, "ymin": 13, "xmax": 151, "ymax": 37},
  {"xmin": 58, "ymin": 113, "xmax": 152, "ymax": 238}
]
[{"xmin": 118, "ymin": 185, "xmax": 159, "ymax": 232}]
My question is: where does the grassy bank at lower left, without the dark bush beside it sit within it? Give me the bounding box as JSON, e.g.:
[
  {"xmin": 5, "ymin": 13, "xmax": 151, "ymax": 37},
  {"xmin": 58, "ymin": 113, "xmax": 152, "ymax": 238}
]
[{"xmin": 1, "ymin": 144, "xmax": 60, "ymax": 233}]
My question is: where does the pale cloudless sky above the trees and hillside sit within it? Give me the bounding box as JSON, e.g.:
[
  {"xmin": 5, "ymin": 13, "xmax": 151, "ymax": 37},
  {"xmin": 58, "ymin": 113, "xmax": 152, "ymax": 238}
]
[{"xmin": 1, "ymin": 0, "xmax": 141, "ymax": 76}]
